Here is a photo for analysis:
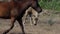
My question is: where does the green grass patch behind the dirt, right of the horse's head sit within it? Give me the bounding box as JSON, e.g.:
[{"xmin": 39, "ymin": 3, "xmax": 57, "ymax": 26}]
[{"xmin": 39, "ymin": 0, "xmax": 60, "ymax": 11}]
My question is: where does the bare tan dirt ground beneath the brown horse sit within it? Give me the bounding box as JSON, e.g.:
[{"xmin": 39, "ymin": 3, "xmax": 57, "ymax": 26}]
[{"xmin": 0, "ymin": 10, "xmax": 60, "ymax": 34}]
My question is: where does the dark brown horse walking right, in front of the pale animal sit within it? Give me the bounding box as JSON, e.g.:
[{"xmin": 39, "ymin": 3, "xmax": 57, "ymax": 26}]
[{"xmin": 0, "ymin": 0, "xmax": 42, "ymax": 34}]
